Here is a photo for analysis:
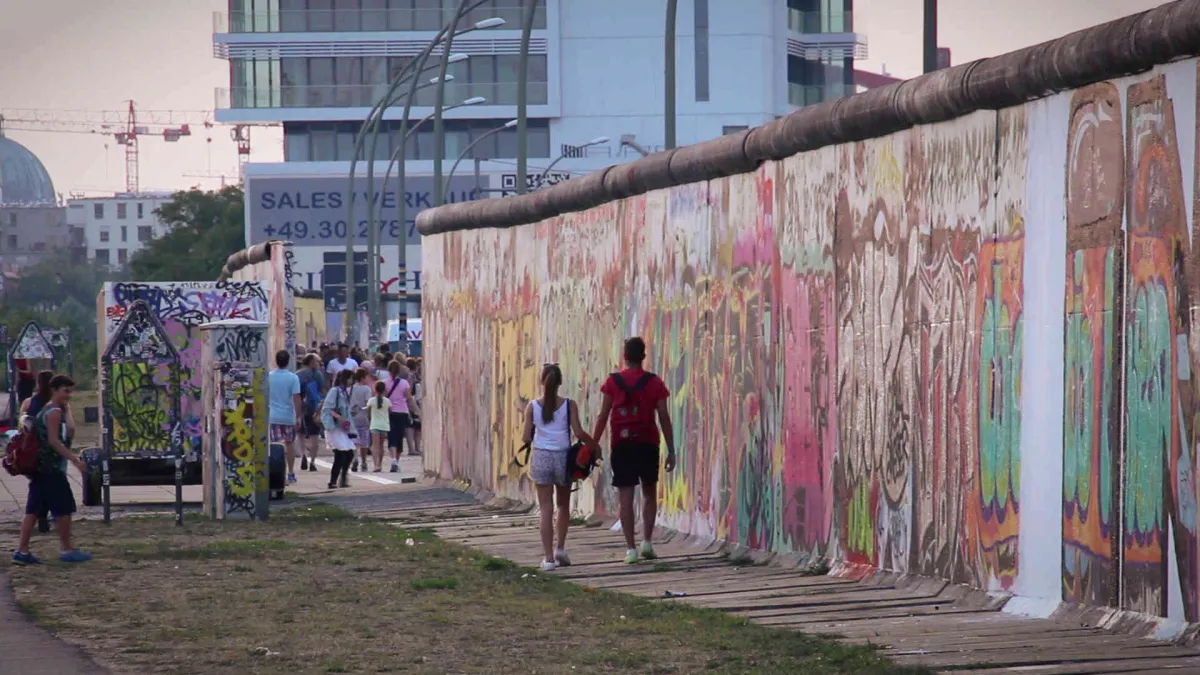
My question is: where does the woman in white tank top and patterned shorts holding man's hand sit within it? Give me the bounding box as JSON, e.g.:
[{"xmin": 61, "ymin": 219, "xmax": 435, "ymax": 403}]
[{"xmin": 524, "ymin": 364, "xmax": 595, "ymax": 572}]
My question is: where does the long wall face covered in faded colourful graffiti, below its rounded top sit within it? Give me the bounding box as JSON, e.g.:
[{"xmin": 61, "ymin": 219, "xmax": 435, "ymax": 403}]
[{"xmin": 424, "ymin": 59, "xmax": 1200, "ymax": 621}]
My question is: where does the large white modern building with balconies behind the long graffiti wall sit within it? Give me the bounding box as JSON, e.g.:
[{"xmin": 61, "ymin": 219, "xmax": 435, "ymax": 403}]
[{"xmin": 214, "ymin": 0, "xmax": 866, "ymax": 328}]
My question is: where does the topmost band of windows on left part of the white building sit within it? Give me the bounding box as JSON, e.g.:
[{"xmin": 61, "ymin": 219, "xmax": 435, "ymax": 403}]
[{"xmin": 228, "ymin": 0, "xmax": 546, "ymax": 32}]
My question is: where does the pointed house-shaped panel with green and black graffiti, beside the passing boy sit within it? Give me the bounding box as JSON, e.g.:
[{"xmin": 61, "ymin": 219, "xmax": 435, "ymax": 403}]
[{"xmin": 100, "ymin": 301, "xmax": 181, "ymax": 459}]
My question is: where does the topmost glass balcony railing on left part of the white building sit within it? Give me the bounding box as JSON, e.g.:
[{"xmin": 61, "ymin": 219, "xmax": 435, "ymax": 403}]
[{"xmin": 212, "ymin": 0, "xmax": 546, "ymax": 34}]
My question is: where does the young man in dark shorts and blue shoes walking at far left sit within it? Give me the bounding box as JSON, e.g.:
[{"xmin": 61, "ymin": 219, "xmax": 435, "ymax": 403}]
[{"xmin": 12, "ymin": 375, "xmax": 91, "ymax": 565}]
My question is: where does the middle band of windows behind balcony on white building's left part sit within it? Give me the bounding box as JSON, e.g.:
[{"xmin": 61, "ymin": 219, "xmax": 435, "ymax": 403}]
[{"xmin": 220, "ymin": 54, "xmax": 550, "ymax": 109}]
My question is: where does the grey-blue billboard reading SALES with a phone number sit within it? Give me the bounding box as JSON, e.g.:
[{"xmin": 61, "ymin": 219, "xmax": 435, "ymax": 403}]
[{"xmin": 246, "ymin": 168, "xmax": 479, "ymax": 246}]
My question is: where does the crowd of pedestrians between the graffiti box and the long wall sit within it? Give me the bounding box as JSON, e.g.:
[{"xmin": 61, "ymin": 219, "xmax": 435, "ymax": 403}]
[{"xmin": 269, "ymin": 342, "xmax": 424, "ymax": 489}]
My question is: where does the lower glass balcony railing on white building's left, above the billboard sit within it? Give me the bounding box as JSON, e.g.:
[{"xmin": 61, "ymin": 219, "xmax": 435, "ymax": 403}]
[{"xmin": 216, "ymin": 82, "xmax": 548, "ymax": 110}]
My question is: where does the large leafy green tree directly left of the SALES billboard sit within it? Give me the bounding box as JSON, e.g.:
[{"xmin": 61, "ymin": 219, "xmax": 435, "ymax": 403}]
[{"xmin": 130, "ymin": 187, "xmax": 246, "ymax": 281}]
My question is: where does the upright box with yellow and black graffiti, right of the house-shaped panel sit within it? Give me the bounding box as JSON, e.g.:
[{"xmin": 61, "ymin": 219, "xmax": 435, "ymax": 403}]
[{"xmin": 200, "ymin": 319, "xmax": 269, "ymax": 520}]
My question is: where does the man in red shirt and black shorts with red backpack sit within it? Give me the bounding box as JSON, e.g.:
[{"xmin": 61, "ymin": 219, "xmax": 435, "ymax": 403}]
[{"xmin": 592, "ymin": 338, "xmax": 676, "ymax": 565}]
